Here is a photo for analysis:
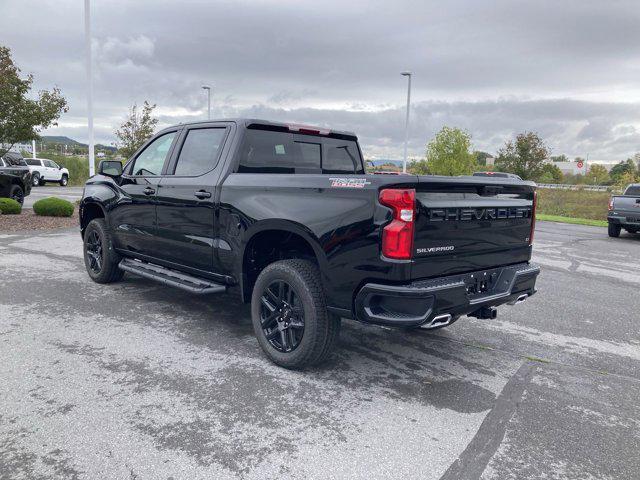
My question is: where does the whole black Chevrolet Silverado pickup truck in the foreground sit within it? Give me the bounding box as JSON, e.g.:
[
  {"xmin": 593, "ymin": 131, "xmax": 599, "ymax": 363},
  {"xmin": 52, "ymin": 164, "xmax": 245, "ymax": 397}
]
[{"xmin": 80, "ymin": 119, "xmax": 539, "ymax": 368}]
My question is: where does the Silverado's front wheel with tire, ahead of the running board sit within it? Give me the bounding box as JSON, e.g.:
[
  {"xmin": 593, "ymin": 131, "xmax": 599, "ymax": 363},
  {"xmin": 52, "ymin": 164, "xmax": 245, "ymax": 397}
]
[{"xmin": 83, "ymin": 218, "xmax": 124, "ymax": 283}]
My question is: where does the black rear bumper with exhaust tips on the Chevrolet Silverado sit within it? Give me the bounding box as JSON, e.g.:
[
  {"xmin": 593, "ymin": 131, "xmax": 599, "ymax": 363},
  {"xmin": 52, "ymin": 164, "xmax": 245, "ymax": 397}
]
[{"xmin": 355, "ymin": 263, "xmax": 540, "ymax": 327}]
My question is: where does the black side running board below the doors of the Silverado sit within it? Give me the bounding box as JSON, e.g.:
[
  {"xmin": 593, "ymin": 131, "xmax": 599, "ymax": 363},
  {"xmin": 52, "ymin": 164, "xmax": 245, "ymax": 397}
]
[{"xmin": 118, "ymin": 258, "xmax": 227, "ymax": 294}]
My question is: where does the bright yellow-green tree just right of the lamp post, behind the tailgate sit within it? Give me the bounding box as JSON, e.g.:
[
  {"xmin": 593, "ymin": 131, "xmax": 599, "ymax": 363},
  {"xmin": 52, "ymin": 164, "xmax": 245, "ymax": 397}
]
[{"xmin": 426, "ymin": 126, "xmax": 477, "ymax": 176}]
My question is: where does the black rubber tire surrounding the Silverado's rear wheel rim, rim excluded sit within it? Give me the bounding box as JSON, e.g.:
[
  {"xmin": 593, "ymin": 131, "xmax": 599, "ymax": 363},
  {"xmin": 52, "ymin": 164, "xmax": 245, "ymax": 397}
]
[{"xmin": 251, "ymin": 259, "xmax": 341, "ymax": 369}]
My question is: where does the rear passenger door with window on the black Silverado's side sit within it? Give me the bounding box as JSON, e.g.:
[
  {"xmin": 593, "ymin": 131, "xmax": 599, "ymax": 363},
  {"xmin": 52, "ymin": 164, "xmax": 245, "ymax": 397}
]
[{"xmin": 157, "ymin": 122, "xmax": 231, "ymax": 273}]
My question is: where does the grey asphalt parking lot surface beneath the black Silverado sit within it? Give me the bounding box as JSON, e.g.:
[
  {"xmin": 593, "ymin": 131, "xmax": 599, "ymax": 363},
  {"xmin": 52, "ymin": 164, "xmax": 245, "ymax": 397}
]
[{"xmin": 0, "ymin": 223, "xmax": 640, "ymax": 480}]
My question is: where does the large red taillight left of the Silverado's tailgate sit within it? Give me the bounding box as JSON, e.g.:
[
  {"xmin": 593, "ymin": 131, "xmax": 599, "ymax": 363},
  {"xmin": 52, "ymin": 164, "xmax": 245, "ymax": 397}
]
[{"xmin": 378, "ymin": 188, "xmax": 416, "ymax": 260}]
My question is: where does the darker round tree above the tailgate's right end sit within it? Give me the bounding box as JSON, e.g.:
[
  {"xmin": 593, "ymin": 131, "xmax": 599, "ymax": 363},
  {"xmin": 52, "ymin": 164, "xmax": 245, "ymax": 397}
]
[{"xmin": 496, "ymin": 132, "xmax": 549, "ymax": 180}]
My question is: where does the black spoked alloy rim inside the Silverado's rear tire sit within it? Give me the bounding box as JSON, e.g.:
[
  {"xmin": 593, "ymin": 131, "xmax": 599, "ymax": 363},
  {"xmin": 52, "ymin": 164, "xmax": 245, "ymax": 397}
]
[{"xmin": 260, "ymin": 280, "xmax": 304, "ymax": 353}]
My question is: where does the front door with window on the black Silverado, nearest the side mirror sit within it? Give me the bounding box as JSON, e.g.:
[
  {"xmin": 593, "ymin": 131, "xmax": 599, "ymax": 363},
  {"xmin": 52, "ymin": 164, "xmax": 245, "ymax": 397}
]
[{"xmin": 109, "ymin": 130, "xmax": 178, "ymax": 257}]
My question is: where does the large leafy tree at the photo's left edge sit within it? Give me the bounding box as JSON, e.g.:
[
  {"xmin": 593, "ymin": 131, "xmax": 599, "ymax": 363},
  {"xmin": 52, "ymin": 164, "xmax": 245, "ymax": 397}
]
[{"xmin": 0, "ymin": 46, "xmax": 68, "ymax": 156}]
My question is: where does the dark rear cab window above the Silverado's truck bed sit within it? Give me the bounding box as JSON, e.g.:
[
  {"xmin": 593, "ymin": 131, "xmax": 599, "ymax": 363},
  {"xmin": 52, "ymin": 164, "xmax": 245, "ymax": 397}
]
[{"xmin": 238, "ymin": 126, "xmax": 364, "ymax": 174}]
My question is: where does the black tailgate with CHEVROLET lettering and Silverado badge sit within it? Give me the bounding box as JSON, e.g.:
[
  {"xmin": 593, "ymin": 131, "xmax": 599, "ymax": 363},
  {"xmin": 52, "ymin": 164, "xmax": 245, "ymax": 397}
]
[{"xmin": 411, "ymin": 177, "xmax": 535, "ymax": 279}]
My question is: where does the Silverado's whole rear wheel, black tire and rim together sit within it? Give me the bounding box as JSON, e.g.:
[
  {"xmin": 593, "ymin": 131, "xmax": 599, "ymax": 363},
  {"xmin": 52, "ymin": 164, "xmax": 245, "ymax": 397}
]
[{"xmin": 251, "ymin": 259, "xmax": 340, "ymax": 369}]
